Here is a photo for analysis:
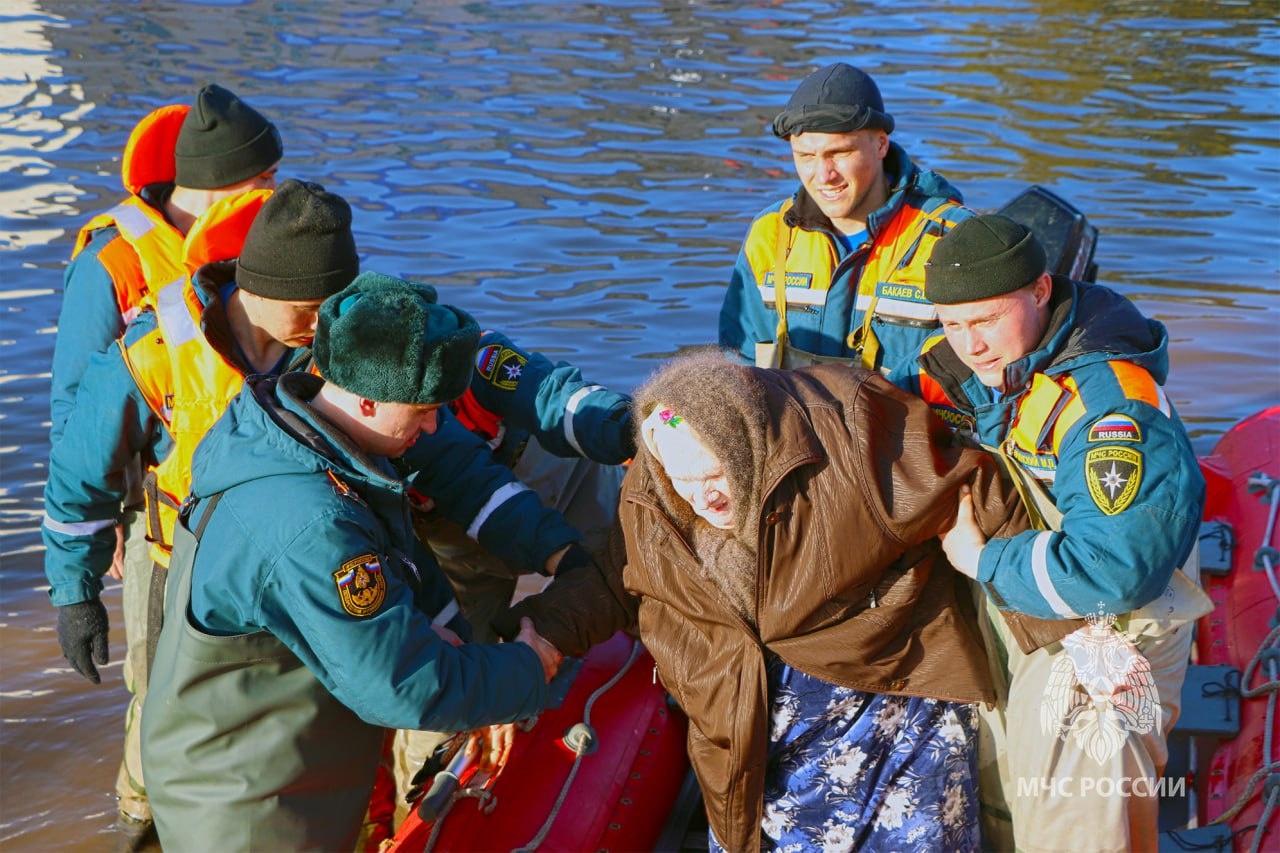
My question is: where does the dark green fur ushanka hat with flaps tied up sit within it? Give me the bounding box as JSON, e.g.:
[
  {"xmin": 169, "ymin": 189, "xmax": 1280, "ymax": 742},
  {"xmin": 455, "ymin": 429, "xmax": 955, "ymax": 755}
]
[{"xmin": 311, "ymin": 273, "xmax": 480, "ymax": 405}]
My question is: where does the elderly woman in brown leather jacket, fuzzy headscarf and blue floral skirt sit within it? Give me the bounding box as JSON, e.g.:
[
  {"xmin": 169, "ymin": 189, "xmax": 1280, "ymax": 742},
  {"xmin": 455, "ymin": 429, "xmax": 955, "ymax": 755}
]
[{"xmin": 512, "ymin": 353, "xmax": 1023, "ymax": 850}]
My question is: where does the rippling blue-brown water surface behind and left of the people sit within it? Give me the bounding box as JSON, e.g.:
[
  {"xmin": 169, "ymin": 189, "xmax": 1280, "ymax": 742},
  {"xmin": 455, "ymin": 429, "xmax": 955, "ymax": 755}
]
[{"xmin": 0, "ymin": 0, "xmax": 1280, "ymax": 849}]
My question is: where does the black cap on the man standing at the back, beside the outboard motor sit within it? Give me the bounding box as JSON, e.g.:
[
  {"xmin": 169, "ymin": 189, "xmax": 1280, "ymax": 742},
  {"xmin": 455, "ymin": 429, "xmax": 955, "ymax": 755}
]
[{"xmin": 773, "ymin": 63, "xmax": 893, "ymax": 140}]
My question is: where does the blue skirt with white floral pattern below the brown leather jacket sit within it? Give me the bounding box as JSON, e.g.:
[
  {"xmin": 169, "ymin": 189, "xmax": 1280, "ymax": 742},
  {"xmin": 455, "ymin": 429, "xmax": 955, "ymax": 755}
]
[{"xmin": 709, "ymin": 658, "xmax": 979, "ymax": 853}]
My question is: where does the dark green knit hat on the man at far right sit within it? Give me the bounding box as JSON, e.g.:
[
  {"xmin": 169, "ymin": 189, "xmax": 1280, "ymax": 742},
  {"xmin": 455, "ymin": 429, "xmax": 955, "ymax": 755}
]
[{"xmin": 924, "ymin": 214, "xmax": 1046, "ymax": 305}]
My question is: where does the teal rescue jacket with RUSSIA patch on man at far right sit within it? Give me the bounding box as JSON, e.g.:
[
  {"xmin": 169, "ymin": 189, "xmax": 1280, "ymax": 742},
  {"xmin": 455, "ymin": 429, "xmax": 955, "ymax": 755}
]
[{"xmin": 890, "ymin": 275, "xmax": 1204, "ymax": 619}]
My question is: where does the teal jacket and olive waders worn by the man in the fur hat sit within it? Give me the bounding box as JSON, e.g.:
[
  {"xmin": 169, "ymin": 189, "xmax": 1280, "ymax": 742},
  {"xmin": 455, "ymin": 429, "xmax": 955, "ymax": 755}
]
[{"xmin": 142, "ymin": 373, "xmax": 548, "ymax": 849}]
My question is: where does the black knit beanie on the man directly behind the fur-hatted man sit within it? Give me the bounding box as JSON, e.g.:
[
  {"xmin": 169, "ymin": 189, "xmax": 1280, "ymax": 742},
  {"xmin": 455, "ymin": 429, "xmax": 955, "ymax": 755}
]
[{"xmin": 236, "ymin": 178, "xmax": 360, "ymax": 301}]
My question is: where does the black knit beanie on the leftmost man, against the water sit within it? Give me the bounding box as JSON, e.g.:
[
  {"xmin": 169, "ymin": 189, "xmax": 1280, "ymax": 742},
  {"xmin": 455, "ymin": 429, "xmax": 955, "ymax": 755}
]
[{"xmin": 174, "ymin": 83, "xmax": 284, "ymax": 190}]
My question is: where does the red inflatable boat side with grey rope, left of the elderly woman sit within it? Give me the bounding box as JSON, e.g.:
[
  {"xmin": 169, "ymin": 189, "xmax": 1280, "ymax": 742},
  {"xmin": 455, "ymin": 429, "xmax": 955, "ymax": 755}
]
[{"xmin": 383, "ymin": 634, "xmax": 689, "ymax": 853}]
